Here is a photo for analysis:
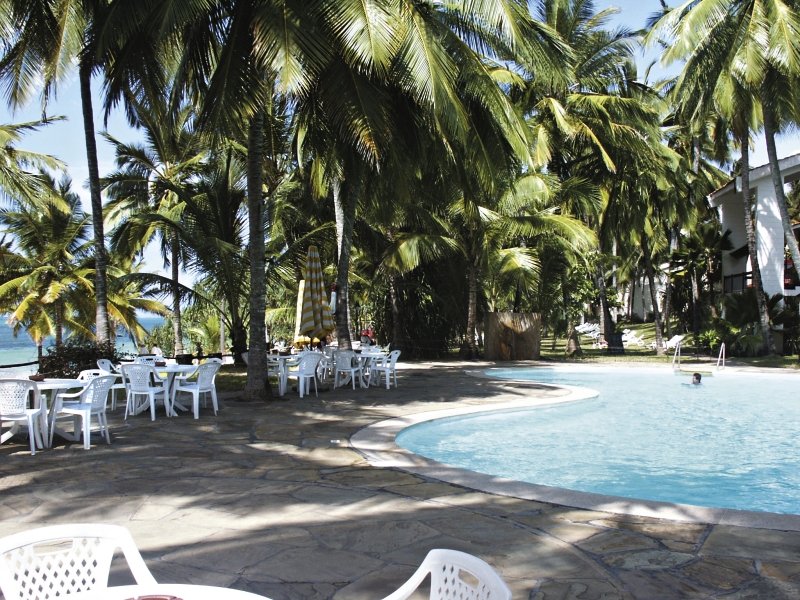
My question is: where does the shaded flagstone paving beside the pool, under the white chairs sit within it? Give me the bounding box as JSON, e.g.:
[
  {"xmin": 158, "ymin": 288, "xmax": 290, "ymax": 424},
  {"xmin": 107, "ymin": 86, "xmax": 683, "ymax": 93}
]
[{"xmin": 0, "ymin": 362, "xmax": 800, "ymax": 600}]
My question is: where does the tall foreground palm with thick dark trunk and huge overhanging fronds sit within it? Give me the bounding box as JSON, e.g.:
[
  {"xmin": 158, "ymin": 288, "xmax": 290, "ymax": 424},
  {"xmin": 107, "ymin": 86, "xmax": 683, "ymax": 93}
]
[{"xmin": 104, "ymin": 0, "xmax": 560, "ymax": 397}]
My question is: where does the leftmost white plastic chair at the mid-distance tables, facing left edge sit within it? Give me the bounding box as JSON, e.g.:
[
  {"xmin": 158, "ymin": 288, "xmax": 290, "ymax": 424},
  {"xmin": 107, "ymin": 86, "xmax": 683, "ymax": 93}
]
[{"xmin": 0, "ymin": 379, "xmax": 47, "ymax": 455}]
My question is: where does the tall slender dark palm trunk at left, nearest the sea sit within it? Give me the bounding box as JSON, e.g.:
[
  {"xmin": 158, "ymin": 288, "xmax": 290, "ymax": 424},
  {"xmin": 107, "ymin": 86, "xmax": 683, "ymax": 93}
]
[{"xmin": 78, "ymin": 58, "xmax": 111, "ymax": 345}]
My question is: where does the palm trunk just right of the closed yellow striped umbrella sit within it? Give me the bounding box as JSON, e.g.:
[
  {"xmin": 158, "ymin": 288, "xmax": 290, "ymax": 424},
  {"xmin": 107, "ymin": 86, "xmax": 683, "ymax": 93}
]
[{"xmin": 333, "ymin": 174, "xmax": 359, "ymax": 349}]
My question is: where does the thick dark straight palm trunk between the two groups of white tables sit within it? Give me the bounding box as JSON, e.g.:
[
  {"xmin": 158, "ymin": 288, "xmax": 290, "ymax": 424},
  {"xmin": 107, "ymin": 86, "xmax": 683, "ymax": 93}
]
[{"xmin": 244, "ymin": 111, "xmax": 269, "ymax": 401}]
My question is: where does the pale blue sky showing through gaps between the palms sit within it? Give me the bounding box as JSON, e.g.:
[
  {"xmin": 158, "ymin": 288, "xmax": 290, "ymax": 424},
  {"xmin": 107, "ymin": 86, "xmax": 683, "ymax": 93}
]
[{"xmin": 0, "ymin": 0, "xmax": 800, "ymax": 253}]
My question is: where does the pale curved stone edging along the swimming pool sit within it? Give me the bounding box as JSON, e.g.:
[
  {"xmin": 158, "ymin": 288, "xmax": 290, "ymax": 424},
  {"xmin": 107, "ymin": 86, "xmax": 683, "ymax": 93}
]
[{"xmin": 350, "ymin": 370, "xmax": 800, "ymax": 531}]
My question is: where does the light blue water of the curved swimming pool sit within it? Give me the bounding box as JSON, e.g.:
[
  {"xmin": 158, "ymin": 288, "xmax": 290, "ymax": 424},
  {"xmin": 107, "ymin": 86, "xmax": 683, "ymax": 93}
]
[{"xmin": 397, "ymin": 368, "xmax": 800, "ymax": 514}]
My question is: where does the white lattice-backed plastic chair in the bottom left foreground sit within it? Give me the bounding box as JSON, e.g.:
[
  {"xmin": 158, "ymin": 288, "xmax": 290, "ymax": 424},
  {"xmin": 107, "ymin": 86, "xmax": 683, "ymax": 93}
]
[{"xmin": 0, "ymin": 523, "xmax": 156, "ymax": 600}]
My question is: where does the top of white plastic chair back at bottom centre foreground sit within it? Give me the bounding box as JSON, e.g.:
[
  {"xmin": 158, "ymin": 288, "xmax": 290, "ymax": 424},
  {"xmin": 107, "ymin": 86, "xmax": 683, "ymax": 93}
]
[{"xmin": 383, "ymin": 549, "xmax": 511, "ymax": 600}]
